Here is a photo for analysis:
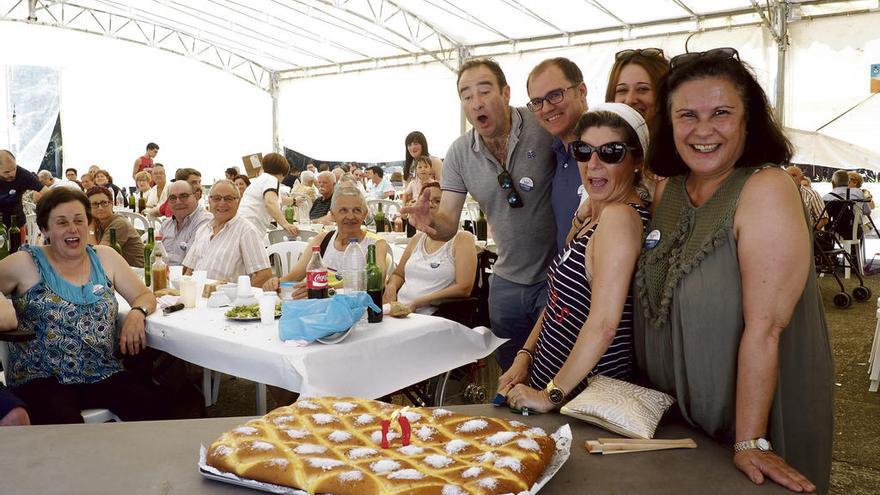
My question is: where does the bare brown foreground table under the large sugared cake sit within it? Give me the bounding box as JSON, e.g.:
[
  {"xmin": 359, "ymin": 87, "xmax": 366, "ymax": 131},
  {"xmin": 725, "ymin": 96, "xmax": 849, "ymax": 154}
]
[{"xmin": 0, "ymin": 405, "xmax": 787, "ymax": 495}]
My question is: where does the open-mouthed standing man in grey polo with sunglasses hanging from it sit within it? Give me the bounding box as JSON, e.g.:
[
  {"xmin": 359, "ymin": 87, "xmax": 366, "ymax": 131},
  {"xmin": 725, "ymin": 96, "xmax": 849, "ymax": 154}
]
[{"xmin": 403, "ymin": 59, "xmax": 556, "ymax": 369}]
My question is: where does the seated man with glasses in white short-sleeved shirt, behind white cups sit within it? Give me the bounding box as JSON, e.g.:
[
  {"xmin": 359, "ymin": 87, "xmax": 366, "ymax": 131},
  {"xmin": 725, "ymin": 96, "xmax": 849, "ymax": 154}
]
[{"xmin": 183, "ymin": 179, "xmax": 272, "ymax": 287}]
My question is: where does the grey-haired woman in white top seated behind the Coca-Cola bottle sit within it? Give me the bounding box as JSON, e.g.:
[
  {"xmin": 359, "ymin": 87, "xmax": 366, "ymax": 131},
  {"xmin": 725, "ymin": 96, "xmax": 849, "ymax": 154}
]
[{"xmin": 263, "ymin": 187, "xmax": 388, "ymax": 298}]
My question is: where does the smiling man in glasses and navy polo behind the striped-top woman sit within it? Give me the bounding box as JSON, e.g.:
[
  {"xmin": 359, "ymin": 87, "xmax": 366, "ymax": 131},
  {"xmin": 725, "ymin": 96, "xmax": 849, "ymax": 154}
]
[{"xmin": 526, "ymin": 57, "xmax": 587, "ymax": 252}]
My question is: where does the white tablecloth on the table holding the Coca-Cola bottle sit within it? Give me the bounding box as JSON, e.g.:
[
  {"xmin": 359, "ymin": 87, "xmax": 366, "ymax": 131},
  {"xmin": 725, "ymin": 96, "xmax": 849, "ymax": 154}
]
[{"xmin": 119, "ymin": 299, "xmax": 504, "ymax": 398}]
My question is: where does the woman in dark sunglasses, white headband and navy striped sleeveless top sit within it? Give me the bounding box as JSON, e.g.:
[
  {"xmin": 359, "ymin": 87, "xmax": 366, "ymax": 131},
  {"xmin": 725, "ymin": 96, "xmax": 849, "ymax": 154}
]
[{"xmin": 498, "ymin": 103, "xmax": 649, "ymax": 411}]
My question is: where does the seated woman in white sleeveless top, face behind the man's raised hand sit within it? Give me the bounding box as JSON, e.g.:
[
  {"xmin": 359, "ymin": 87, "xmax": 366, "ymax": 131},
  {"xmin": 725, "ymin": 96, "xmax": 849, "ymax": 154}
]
[{"xmin": 385, "ymin": 182, "xmax": 477, "ymax": 314}]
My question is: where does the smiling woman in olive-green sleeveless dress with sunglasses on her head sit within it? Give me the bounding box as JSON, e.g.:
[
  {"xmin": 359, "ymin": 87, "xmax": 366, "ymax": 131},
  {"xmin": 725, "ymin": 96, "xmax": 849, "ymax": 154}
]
[{"xmin": 635, "ymin": 48, "xmax": 834, "ymax": 493}]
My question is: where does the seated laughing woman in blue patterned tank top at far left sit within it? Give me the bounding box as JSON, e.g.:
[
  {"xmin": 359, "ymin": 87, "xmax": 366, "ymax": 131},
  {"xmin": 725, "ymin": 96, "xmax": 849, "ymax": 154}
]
[{"xmin": 0, "ymin": 187, "xmax": 169, "ymax": 424}]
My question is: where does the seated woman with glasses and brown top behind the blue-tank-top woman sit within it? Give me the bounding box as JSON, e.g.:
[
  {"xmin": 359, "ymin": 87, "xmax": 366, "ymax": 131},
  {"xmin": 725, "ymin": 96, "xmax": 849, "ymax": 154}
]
[{"xmin": 86, "ymin": 186, "xmax": 144, "ymax": 268}]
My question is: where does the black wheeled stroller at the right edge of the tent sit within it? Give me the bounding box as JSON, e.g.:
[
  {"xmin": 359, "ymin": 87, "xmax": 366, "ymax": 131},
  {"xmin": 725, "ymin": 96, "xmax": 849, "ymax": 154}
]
[{"xmin": 813, "ymin": 199, "xmax": 876, "ymax": 309}]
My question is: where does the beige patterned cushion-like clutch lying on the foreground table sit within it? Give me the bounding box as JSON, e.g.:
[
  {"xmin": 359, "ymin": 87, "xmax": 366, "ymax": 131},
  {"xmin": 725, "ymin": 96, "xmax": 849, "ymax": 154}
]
[{"xmin": 561, "ymin": 375, "xmax": 675, "ymax": 438}]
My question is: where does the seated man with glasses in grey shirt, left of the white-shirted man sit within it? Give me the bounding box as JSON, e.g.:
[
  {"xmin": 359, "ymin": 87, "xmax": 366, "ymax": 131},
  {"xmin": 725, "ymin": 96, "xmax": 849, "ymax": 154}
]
[{"xmin": 159, "ymin": 180, "xmax": 213, "ymax": 265}]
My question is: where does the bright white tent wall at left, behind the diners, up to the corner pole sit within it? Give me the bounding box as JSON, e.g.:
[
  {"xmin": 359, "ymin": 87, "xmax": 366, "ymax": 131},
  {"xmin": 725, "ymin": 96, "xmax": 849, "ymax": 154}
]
[{"xmin": 0, "ymin": 23, "xmax": 272, "ymax": 185}]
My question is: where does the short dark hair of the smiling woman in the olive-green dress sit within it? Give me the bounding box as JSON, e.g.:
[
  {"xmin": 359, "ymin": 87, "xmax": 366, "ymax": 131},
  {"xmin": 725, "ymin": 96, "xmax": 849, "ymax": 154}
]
[{"xmin": 647, "ymin": 56, "xmax": 793, "ymax": 177}]
